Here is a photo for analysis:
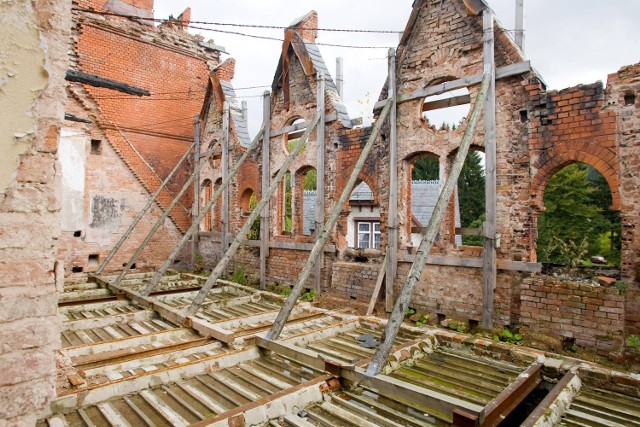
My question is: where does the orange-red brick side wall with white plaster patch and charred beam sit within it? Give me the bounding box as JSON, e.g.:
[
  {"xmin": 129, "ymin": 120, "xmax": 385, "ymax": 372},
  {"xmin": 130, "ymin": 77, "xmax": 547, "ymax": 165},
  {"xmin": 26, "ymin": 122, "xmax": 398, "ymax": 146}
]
[{"xmin": 60, "ymin": 0, "xmax": 221, "ymax": 273}]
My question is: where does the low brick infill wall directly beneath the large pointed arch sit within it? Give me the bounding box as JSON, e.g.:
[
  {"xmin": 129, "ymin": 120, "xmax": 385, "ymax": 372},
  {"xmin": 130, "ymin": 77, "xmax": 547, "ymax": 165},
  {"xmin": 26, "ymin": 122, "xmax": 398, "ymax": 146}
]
[{"xmin": 520, "ymin": 278, "xmax": 624, "ymax": 356}]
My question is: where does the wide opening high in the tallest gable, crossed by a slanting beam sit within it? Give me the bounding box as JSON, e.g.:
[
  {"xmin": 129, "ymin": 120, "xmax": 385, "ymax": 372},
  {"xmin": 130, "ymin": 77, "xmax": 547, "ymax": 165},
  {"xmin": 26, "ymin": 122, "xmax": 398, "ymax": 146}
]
[{"xmin": 422, "ymin": 88, "xmax": 471, "ymax": 130}]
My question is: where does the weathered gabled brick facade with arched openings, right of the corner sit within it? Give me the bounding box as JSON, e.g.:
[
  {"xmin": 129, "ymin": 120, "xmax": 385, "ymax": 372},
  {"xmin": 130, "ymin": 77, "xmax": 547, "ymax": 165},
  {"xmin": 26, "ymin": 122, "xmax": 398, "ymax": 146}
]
[{"xmin": 201, "ymin": 0, "xmax": 640, "ymax": 346}]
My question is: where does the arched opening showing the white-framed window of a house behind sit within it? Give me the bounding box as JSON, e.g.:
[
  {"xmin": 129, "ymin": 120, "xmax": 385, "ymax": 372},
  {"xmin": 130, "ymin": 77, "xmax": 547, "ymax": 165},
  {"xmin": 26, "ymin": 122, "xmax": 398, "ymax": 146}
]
[{"xmin": 347, "ymin": 181, "xmax": 381, "ymax": 249}]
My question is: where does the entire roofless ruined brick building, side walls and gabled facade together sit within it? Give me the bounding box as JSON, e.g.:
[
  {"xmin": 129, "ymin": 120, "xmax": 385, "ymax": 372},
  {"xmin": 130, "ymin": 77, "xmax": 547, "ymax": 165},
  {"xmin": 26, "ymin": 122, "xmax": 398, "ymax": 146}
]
[{"xmin": 0, "ymin": 0, "xmax": 640, "ymax": 425}]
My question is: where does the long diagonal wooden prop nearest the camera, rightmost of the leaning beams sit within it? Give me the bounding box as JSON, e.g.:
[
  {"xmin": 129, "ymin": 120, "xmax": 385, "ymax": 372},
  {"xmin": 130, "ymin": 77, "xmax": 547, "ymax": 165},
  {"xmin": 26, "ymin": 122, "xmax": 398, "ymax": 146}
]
[{"xmin": 366, "ymin": 72, "xmax": 491, "ymax": 376}]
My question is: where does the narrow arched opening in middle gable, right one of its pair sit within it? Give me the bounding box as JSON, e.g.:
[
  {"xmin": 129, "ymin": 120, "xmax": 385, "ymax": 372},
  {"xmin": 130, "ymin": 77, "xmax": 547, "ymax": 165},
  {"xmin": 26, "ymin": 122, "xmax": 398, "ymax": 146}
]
[{"xmin": 293, "ymin": 166, "xmax": 318, "ymax": 236}]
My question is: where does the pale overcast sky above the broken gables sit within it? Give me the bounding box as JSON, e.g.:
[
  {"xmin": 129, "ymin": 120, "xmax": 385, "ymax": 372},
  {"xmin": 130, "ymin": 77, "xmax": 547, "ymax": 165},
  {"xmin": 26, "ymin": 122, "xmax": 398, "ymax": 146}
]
[{"xmin": 155, "ymin": 0, "xmax": 640, "ymax": 134}]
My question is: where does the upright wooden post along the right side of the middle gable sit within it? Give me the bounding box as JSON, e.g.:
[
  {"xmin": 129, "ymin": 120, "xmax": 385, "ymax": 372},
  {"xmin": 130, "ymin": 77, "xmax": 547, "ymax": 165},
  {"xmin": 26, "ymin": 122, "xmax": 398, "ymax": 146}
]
[{"xmin": 314, "ymin": 73, "xmax": 325, "ymax": 294}]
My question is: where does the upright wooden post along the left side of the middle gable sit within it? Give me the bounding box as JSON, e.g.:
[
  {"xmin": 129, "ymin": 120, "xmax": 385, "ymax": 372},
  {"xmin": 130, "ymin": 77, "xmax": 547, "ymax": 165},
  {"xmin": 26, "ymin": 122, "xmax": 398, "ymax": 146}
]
[{"xmin": 260, "ymin": 90, "xmax": 271, "ymax": 290}]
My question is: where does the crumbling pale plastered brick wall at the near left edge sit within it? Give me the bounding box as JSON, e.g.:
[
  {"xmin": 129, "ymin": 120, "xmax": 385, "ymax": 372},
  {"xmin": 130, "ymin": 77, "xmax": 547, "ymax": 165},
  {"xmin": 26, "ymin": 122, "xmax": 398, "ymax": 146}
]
[{"xmin": 0, "ymin": 1, "xmax": 71, "ymax": 425}]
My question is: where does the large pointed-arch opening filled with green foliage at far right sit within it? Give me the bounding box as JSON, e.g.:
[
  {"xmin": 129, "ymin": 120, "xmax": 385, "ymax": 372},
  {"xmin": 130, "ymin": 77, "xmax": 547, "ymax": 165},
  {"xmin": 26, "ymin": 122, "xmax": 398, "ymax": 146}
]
[{"xmin": 536, "ymin": 162, "xmax": 621, "ymax": 269}]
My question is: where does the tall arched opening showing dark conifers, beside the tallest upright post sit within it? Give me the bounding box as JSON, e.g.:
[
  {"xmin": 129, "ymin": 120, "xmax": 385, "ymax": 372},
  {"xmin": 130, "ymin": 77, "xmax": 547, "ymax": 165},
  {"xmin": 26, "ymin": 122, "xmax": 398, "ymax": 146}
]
[{"xmin": 455, "ymin": 149, "xmax": 486, "ymax": 246}]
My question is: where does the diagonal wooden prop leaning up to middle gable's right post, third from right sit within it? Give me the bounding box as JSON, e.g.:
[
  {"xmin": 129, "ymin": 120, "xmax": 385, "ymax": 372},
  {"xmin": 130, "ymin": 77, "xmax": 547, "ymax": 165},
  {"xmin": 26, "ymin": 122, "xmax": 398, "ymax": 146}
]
[{"xmin": 184, "ymin": 116, "xmax": 319, "ymax": 316}]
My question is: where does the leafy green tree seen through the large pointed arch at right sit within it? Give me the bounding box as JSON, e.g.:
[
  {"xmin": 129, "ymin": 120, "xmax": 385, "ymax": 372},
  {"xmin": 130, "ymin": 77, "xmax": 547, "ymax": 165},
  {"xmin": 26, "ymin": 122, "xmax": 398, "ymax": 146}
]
[{"xmin": 538, "ymin": 163, "xmax": 610, "ymax": 262}]
